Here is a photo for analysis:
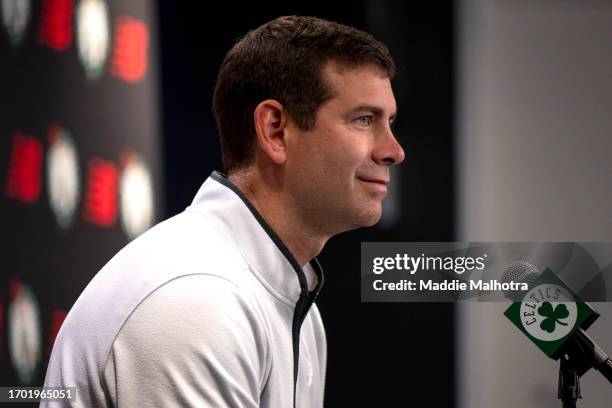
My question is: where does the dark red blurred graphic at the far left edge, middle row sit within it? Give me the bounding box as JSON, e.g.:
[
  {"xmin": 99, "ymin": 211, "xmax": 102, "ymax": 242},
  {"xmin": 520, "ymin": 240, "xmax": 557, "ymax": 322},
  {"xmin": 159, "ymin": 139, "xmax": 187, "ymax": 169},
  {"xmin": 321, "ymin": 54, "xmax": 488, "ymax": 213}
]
[{"xmin": 6, "ymin": 133, "xmax": 43, "ymax": 204}]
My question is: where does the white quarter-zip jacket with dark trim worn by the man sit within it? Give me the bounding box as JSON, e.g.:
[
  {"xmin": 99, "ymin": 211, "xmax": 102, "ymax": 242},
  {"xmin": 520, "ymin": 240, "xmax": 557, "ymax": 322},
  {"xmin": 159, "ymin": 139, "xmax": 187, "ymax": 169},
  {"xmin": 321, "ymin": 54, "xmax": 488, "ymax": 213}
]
[{"xmin": 41, "ymin": 172, "xmax": 327, "ymax": 408}]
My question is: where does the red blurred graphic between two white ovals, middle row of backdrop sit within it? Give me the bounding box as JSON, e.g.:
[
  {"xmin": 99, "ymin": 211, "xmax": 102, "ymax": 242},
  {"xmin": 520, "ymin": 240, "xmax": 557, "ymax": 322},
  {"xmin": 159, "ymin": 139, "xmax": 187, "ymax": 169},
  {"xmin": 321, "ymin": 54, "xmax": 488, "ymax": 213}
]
[{"xmin": 83, "ymin": 158, "xmax": 118, "ymax": 227}]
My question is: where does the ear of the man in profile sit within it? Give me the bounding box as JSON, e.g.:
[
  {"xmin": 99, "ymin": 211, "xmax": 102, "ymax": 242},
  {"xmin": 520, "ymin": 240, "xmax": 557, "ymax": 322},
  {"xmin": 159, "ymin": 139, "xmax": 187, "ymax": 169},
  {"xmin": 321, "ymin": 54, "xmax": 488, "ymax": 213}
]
[{"xmin": 253, "ymin": 99, "xmax": 287, "ymax": 164}]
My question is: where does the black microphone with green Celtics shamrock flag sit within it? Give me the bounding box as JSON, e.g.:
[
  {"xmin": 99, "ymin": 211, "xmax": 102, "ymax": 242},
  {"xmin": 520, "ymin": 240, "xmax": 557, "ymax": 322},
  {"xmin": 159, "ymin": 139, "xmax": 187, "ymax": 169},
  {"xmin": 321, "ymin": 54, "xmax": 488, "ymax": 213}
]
[{"xmin": 502, "ymin": 261, "xmax": 612, "ymax": 383}]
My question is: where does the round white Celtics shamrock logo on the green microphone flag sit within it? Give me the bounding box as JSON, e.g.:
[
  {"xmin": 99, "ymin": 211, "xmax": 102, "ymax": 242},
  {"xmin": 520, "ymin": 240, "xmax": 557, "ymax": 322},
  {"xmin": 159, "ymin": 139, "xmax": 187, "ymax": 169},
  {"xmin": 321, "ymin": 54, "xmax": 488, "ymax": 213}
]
[{"xmin": 520, "ymin": 284, "xmax": 578, "ymax": 341}]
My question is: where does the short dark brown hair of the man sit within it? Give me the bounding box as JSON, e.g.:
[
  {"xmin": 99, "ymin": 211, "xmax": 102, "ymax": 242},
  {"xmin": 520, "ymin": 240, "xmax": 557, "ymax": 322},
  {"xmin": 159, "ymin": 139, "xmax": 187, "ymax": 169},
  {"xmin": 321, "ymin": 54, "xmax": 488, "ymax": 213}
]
[{"xmin": 213, "ymin": 16, "xmax": 395, "ymax": 172}]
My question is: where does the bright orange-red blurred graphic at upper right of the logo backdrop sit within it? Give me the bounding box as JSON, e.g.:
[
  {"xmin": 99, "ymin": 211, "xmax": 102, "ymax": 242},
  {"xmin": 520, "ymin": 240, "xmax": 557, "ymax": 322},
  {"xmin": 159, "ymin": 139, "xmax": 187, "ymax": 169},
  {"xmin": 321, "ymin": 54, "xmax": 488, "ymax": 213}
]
[{"xmin": 111, "ymin": 16, "xmax": 149, "ymax": 82}]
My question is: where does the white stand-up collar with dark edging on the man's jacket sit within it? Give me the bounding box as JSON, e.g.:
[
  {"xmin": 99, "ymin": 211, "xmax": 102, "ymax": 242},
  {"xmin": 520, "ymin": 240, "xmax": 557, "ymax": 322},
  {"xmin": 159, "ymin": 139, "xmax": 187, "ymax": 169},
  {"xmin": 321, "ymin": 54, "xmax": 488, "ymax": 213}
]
[{"xmin": 190, "ymin": 171, "xmax": 323, "ymax": 304}]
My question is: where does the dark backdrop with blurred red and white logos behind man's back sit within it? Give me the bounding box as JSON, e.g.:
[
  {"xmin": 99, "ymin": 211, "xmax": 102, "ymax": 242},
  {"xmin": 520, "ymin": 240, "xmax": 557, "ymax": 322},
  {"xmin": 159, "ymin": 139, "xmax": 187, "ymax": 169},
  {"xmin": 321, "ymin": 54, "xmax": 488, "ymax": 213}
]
[{"xmin": 0, "ymin": 0, "xmax": 166, "ymax": 398}]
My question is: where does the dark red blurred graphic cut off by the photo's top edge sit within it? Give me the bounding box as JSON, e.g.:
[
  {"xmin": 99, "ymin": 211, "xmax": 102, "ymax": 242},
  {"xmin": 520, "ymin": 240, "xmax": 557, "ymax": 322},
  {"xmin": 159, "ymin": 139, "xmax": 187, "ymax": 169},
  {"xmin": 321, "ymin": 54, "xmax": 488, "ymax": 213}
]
[{"xmin": 38, "ymin": 0, "xmax": 74, "ymax": 51}]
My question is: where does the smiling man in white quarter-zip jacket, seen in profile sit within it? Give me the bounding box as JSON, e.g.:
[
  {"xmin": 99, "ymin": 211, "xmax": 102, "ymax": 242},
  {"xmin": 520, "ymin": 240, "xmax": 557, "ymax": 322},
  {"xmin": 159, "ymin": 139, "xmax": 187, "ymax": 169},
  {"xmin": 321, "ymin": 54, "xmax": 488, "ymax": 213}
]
[{"xmin": 43, "ymin": 17, "xmax": 404, "ymax": 408}]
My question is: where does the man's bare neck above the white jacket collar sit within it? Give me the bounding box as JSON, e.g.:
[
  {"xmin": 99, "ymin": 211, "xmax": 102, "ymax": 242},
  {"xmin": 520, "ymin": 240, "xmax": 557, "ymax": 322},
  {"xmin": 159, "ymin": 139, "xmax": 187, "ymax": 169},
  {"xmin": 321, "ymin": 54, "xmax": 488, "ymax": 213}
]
[{"xmin": 228, "ymin": 170, "xmax": 329, "ymax": 266}]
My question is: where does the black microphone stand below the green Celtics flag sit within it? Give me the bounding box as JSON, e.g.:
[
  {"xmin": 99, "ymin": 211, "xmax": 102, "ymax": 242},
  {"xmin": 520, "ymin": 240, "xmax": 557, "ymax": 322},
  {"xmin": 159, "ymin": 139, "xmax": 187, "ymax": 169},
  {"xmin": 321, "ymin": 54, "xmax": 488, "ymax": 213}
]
[{"xmin": 557, "ymin": 329, "xmax": 612, "ymax": 408}]
